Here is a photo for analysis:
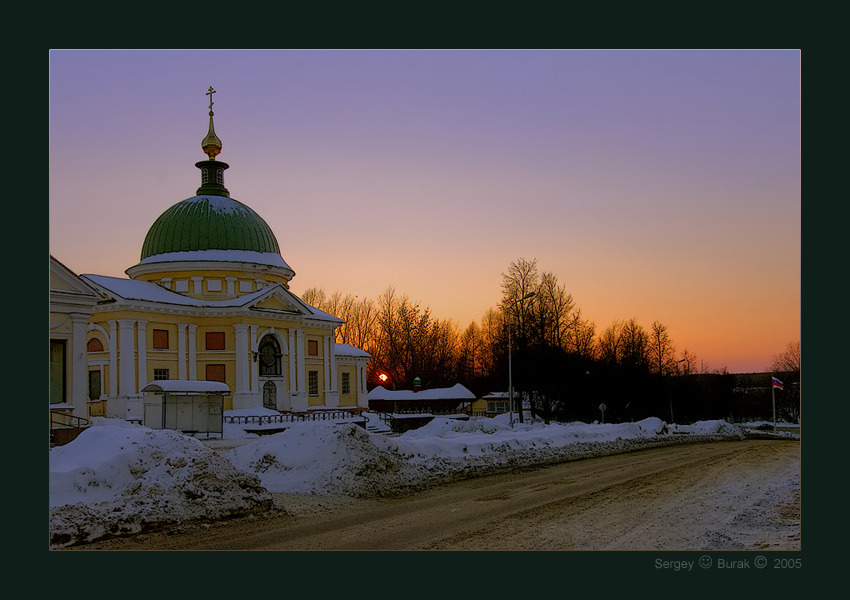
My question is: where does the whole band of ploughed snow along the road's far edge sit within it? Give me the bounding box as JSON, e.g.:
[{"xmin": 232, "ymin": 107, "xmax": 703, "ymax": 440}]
[{"xmin": 49, "ymin": 409, "xmax": 794, "ymax": 548}]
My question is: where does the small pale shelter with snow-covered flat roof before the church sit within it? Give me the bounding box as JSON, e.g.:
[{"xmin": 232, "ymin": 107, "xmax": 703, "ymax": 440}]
[{"xmin": 142, "ymin": 379, "xmax": 230, "ymax": 435}]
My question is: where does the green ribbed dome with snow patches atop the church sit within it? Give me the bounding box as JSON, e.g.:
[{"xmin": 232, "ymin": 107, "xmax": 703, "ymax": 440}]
[{"xmin": 142, "ymin": 195, "xmax": 280, "ymax": 261}]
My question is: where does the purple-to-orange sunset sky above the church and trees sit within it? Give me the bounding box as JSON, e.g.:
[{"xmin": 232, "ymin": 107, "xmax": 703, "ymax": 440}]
[{"xmin": 49, "ymin": 50, "xmax": 801, "ymax": 372}]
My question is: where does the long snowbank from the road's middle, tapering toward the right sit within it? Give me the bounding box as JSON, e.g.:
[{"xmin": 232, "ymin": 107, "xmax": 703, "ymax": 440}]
[{"xmin": 226, "ymin": 417, "xmax": 743, "ymax": 497}]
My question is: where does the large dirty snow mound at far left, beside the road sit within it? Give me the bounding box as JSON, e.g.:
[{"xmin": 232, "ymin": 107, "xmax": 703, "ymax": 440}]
[{"xmin": 49, "ymin": 419, "xmax": 273, "ymax": 547}]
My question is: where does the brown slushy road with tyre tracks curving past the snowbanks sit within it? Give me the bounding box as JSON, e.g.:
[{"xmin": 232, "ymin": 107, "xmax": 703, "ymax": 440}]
[{"xmin": 67, "ymin": 440, "xmax": 801, "ymax": 550}]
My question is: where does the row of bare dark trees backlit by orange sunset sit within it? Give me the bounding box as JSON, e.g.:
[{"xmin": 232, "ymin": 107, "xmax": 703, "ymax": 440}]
[{"xmin": 302, "ymin": 258, "xmax": 796, "ymax": 422}]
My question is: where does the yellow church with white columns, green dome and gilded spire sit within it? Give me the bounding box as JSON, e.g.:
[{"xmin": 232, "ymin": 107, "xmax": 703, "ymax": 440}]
[{"xmin": 51, "ymin": 88, "xmax": 369, "ymax": 420}]
